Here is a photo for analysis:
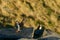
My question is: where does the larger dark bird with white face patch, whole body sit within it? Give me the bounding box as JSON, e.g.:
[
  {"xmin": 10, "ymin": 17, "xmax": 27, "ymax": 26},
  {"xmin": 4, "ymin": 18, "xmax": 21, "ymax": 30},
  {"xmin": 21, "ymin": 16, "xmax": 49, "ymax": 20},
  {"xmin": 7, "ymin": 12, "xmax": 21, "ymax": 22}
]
[{"xmin": 33, "ymin": 25, "xmax": 45, "ymax": 39}]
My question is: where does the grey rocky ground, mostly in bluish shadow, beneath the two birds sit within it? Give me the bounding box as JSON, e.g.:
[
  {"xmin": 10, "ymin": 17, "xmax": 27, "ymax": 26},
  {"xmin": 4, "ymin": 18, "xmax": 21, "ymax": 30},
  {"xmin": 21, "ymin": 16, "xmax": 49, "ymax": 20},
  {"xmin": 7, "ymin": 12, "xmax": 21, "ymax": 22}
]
[{"xmin": 0, "ymin": 28, "xmax": 60, "ymax": 40}]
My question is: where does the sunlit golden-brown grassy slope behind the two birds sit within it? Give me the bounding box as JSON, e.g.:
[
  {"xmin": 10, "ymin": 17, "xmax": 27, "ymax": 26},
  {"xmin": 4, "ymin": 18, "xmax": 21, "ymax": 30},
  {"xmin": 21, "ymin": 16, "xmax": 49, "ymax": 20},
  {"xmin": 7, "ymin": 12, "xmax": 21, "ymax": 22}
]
[{"xmin": 0, "ymin": 0, "xmax": 60, "ymax": 33}]
